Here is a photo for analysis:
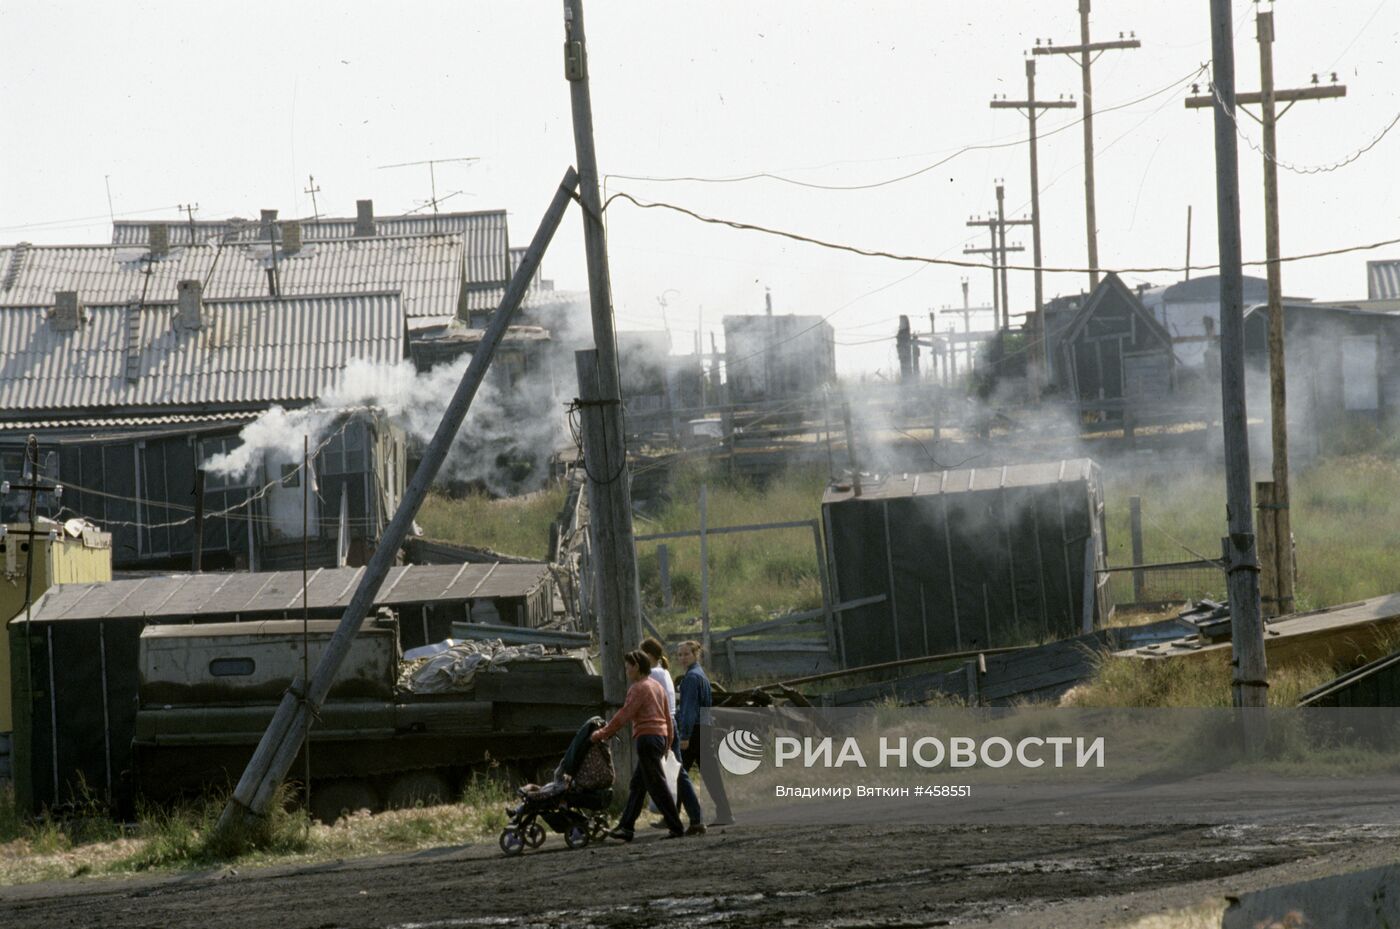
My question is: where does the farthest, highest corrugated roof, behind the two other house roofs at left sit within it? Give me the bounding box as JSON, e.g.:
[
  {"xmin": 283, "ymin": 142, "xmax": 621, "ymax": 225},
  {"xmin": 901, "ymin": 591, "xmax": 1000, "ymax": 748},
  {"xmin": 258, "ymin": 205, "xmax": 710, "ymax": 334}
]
[{"xmin": 112, "ymin": 210, "xmax": 509, "ymax": 287}]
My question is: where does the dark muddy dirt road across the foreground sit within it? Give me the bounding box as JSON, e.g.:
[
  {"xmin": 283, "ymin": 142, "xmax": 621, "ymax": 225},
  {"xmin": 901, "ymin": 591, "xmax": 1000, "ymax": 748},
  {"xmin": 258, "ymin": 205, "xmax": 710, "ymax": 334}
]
[{"xmin": 0, "ymin": 825, "xmax": 1394, "ymax": 929}]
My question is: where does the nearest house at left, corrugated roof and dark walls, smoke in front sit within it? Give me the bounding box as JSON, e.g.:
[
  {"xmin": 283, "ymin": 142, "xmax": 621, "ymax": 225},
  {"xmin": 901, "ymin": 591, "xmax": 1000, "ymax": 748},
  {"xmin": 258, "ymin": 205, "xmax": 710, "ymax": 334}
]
[{"xmin": 0, "ymin": 288, "xmax": 406, "ymax": 569}]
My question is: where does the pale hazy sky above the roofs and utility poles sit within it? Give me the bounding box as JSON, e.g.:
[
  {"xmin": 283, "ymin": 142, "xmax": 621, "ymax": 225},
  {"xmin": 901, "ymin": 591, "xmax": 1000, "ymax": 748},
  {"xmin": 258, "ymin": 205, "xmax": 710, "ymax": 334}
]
[{"xmin": 0, "ymin": 0, "xmax": 1400, "ymax": 371}]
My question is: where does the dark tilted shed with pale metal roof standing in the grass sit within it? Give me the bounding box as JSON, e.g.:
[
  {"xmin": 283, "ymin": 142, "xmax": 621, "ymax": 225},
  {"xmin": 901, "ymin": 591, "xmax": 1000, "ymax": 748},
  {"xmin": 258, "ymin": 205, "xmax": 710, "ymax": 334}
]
[{"xmin": 822, "ymin": 459, "xmax": 1113, "ymax": 667}]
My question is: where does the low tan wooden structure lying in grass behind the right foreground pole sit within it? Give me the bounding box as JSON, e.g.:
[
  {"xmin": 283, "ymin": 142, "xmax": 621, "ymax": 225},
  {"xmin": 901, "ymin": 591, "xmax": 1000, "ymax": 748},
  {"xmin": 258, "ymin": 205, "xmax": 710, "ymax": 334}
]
[{"xmin": 1117, "ymin": 593, "xmax": 1400, "ymax": 665}]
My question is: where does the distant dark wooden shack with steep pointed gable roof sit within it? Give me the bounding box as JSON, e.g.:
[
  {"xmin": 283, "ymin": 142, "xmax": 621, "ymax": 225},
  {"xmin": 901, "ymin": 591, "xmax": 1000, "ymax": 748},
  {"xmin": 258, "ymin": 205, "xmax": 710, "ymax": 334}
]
[{"xmin": 1051, "ymin": 273, "xmax": 1176, "ymax": 420}]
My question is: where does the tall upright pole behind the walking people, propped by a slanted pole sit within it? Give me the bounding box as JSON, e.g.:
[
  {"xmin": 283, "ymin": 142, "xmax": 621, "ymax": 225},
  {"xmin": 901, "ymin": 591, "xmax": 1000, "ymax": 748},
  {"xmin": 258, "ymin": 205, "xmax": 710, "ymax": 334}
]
[{"xmin": 564, "ymin": 0, "xmax": 641, "ymax": 710}]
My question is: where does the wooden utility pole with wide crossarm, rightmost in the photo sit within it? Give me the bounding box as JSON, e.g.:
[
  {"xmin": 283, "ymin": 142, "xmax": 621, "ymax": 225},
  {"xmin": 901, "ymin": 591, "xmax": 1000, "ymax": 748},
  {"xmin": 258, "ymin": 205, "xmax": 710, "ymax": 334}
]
[{"xmin": 1186, "ymin": 10, "xmax": 1347, "ymax": 616}]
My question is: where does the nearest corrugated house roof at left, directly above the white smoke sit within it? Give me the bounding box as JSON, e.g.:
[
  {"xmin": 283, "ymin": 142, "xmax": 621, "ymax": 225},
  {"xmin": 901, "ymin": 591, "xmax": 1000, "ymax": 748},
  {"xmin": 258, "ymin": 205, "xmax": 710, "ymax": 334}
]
[{"xmin": 0, "ymin": 294, "xmax": 403, "ymax": 418}]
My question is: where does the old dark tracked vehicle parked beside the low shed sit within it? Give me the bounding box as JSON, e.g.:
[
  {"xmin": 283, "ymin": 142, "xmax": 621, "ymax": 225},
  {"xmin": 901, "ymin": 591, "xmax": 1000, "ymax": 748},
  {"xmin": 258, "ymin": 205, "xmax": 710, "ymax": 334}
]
[{"xmin": 133, "ymin": 617, "xmax": 602, "ymax": 821}]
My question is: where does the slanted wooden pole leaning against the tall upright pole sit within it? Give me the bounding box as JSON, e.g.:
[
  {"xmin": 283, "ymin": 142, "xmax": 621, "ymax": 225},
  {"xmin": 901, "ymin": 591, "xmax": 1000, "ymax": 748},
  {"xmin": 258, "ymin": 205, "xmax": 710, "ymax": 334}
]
[{"xmin": 217, "ymin": 168, "xmax": 578, "ymax": 835}]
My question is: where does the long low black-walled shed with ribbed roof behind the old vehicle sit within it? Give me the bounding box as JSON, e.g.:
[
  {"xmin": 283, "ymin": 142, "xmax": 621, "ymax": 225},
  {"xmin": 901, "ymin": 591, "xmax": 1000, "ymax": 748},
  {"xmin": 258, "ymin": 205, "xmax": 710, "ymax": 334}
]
[{"xmin": 6, "ymin": 564, "xmax": 553, "ymax": 810}]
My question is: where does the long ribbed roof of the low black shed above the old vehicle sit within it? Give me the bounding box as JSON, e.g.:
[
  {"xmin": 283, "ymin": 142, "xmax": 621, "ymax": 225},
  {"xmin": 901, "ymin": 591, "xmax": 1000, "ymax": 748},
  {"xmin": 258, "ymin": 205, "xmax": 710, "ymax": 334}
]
[{"xmin": 20, "ymin": 564, "xmax": 549, "ymax": 623}]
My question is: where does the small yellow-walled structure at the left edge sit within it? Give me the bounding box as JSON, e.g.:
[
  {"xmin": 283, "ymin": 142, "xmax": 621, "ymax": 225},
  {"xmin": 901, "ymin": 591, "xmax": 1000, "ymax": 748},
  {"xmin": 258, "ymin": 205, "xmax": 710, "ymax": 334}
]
[{"xmin": 0, "ymin": 522, "xmax": 112, "ymax": 732}]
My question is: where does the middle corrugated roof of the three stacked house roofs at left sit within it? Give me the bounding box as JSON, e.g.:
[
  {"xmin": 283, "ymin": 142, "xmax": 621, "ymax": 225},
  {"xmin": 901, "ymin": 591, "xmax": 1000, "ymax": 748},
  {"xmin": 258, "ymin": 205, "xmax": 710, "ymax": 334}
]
[{"xmin": 0, "ymin": 235, "xmax": 463, "ymax": 319}]
